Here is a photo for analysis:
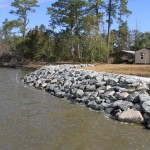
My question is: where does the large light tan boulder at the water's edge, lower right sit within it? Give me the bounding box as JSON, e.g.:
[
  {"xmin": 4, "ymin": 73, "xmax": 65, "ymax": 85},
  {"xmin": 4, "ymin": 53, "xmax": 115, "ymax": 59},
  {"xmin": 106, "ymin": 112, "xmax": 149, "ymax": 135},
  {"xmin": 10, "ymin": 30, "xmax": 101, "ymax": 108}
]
[{"xmin": 118, "ymin": 109, "xmax": 144, "ymax": 124}]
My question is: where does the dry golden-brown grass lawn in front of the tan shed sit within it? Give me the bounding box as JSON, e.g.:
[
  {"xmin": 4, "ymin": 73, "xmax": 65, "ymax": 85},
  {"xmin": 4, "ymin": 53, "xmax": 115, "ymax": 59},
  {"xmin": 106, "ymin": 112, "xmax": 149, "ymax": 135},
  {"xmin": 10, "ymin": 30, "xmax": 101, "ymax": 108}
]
[{"xmin": 84, "ymin": 64, "xmax": 150, "ymax": 77}]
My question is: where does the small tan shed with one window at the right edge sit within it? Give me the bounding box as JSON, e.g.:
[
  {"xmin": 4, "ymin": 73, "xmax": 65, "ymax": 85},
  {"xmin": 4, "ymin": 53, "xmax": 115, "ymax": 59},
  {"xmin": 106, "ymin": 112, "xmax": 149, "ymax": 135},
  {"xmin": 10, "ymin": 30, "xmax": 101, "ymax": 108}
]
[{"xmin": 135, "ymin": 48, "xmax": 150, "ymax": 64}]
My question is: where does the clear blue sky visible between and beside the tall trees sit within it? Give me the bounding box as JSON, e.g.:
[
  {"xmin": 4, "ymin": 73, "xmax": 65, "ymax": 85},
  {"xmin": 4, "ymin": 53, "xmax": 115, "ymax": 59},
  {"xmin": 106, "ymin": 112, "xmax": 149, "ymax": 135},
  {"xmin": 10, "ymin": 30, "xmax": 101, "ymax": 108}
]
[{"xmin": 0, "ymin": 0, "xmax": 150, "ymax": 32}]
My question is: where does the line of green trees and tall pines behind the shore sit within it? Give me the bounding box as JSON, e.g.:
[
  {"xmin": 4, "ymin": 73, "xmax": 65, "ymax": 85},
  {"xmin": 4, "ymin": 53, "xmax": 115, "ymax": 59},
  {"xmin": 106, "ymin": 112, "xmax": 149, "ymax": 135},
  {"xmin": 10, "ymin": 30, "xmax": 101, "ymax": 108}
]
[{"xmin": 0, "ymin": 0, "xmax": 150, "ymax": 62}]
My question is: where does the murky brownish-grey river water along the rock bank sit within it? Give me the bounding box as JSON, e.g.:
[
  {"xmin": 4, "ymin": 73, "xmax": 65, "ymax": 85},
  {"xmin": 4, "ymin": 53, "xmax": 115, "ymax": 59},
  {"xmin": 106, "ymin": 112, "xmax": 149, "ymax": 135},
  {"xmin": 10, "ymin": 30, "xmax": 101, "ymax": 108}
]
[{"xmin": 0, "ymin": 68, "xmax": 150, "ymax": 150}]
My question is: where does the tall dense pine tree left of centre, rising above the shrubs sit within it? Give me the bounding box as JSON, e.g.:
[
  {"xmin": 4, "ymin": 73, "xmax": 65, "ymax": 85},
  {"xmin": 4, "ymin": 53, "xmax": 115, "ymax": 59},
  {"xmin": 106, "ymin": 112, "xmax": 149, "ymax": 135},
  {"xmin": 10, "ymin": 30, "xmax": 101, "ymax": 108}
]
[{"xmin": 48, "ymin": 0, "xmax": 86, "ymax": 59}]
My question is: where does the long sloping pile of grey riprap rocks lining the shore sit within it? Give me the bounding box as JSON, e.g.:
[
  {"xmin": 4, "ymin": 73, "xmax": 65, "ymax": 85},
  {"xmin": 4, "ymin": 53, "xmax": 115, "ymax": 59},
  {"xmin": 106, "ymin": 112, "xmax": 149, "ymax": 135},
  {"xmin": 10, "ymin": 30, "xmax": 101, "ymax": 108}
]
[{"xmin": 22, "ymin": 64, "xmax": 150, "ymax": 129}]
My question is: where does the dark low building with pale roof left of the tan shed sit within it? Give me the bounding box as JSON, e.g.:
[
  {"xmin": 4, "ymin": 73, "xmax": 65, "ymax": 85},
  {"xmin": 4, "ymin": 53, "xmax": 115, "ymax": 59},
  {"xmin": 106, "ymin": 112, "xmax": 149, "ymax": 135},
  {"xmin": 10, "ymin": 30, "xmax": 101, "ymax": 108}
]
[{"xmin": 109, "ymin": 50, "xmax": 135, "ymax": 63}]
